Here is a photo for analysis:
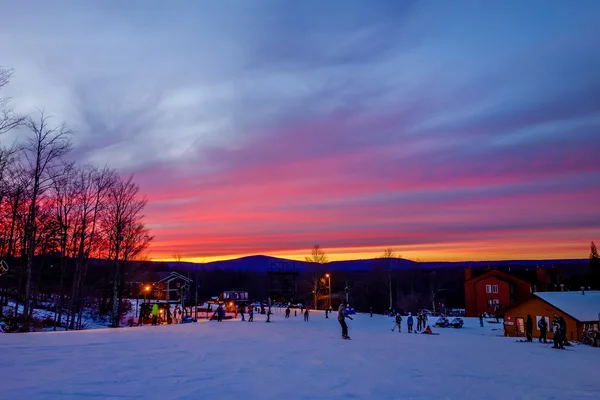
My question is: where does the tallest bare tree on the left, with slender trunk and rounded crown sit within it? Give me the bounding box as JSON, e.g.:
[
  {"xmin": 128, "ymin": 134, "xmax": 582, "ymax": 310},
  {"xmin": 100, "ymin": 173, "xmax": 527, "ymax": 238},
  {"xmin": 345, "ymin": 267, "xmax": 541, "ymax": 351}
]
[{"xmin": 23, "ymin": 111, "xmax": 71, "ymax": 331}]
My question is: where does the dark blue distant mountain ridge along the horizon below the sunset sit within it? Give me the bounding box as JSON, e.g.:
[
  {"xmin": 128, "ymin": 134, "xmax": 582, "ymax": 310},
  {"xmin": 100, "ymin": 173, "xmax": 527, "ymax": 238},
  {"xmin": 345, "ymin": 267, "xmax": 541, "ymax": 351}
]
[{"xmin": 152, "ymin": 255, "xmax": 588, "ymax": 272}]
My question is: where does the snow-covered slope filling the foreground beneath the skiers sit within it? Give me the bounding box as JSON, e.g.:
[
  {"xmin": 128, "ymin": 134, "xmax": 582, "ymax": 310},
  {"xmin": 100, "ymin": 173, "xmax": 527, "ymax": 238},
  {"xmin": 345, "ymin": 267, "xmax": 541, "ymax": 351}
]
[{"xmin": 0, "ymin": 311, "xmax": 600, "ymax": 400}]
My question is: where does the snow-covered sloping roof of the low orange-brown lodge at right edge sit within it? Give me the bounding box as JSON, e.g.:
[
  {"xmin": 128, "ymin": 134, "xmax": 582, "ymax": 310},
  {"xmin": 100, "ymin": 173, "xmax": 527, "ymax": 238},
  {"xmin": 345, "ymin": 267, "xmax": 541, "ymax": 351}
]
[{"xmin": 534, "ymin": 290, "xmax": 600, "ymax": 322}]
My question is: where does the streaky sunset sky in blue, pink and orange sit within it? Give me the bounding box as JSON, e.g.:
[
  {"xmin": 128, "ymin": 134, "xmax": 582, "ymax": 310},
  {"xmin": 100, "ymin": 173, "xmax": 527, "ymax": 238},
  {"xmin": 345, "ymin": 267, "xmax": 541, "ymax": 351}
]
[{"xmin": 0, "ymin": 0, "xmax": 600, "ymax": 262}]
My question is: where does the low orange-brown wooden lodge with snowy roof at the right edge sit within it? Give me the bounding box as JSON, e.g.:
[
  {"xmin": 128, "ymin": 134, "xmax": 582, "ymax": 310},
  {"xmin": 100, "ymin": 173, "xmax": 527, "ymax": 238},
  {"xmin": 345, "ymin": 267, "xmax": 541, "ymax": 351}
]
[{"xmin": 504, "ymin": 290, "xmax": 600, "ymax": 341}]
